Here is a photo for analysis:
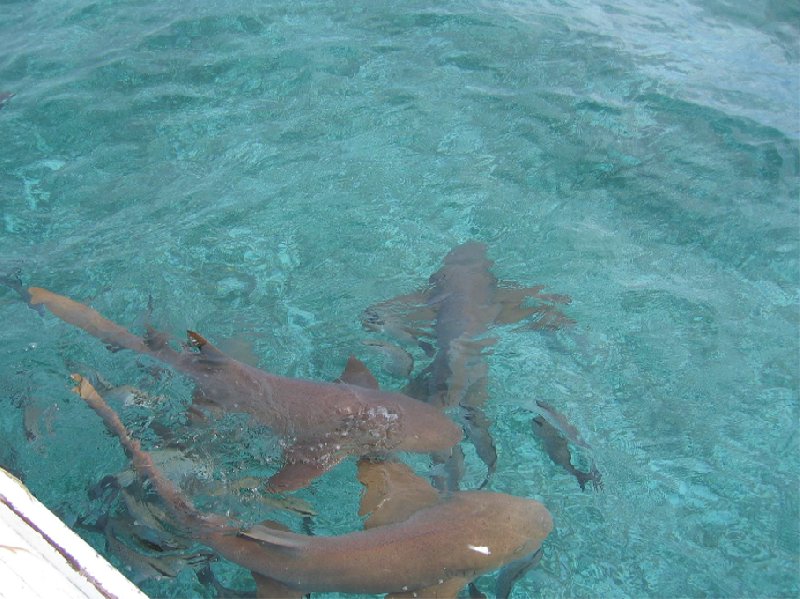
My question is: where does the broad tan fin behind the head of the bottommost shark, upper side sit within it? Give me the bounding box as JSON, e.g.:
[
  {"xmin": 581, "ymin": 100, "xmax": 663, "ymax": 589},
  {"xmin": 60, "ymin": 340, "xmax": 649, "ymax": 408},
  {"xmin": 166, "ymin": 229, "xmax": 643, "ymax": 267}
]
[{"xmin": 358, "ymin": 459, "xmax": 440, "ymax": 528}]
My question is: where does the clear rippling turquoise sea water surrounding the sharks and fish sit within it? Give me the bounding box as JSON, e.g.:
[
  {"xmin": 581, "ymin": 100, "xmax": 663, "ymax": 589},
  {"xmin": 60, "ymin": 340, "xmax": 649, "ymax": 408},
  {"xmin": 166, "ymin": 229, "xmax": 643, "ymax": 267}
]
[{"xmin": 0, "ymin": 0, "xmax": 800, "ymax": 597}]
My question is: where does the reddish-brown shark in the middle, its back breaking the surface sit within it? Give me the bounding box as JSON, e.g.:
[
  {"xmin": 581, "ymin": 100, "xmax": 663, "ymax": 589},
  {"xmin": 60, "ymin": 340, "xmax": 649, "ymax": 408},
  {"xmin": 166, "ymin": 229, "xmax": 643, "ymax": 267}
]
[{"xmin": 22, "ymin": 287, "xmax": 462, "ymax": 492}]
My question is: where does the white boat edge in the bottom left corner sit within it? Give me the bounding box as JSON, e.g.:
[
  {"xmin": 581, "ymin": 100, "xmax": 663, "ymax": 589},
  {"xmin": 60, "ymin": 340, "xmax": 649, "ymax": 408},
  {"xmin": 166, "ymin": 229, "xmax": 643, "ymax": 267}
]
[{"xmin": 0, "ymin": 468, "xmax": 147, "ymax": 599}]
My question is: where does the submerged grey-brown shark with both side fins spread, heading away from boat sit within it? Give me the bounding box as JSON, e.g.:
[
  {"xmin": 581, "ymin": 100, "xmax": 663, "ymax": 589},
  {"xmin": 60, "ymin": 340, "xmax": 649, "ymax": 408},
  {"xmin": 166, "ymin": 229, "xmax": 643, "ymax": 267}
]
[{"xmin": 362, "ymin": 241, "xmax": 572, "ymax": 488}]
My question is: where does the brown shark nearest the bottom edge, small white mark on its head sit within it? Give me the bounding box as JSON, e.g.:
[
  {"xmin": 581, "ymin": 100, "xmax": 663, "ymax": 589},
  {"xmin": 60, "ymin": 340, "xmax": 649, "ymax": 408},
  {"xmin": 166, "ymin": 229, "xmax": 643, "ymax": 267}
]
[{"xmin": 73, "ymin": 375, "xmax": 553, "ymax": 598}]
